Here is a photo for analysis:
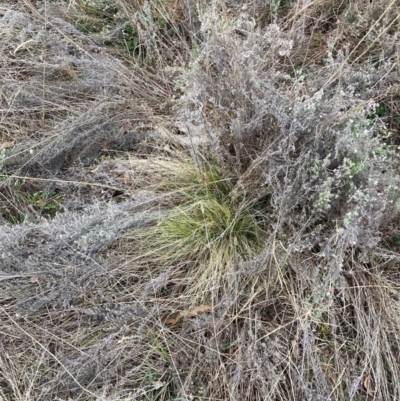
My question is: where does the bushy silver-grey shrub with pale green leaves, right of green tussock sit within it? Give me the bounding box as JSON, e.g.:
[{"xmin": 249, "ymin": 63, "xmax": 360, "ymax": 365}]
[{"xmin": 178, "ymin": 8, "xmax": 399, "ymax": 262}]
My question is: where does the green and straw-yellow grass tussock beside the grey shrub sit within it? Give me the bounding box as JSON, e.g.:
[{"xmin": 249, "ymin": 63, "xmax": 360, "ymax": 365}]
[{"xmin": 134, "ymin": 161, "xmax": 267, "ymax": 299}]
